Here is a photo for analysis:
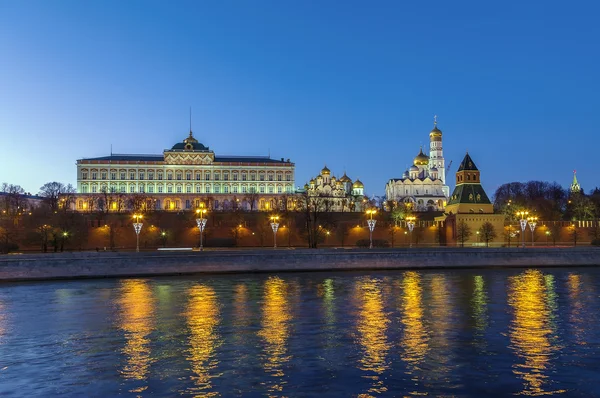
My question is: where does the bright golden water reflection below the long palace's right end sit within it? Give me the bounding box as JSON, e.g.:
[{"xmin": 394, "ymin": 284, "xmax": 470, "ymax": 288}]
[{"xmin": 258, "ymin": 277, "xmax": 292, "ymax": 396}]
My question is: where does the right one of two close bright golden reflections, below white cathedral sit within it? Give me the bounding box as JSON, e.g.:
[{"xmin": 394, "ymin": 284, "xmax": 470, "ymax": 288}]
[{"xmin": 401, "ymin": 271, "xmax": 429, "ymax": 373}]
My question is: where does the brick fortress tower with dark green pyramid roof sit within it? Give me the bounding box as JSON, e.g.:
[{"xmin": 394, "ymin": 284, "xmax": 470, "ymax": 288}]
[{"xmin": 436, "ymin": 153, "xmax": 504, "ymax": 246}]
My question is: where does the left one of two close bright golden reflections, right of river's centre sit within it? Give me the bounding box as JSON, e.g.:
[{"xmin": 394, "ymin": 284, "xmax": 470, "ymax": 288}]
[{"xmin": 356, "ymin": 278, "xmax": 390, "ymax": 397}]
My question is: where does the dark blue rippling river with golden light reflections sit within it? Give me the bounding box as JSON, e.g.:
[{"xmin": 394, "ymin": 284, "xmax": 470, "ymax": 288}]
[{"xmin": 0, "ymin": 268, "xmax": 600, "ymax": 397}]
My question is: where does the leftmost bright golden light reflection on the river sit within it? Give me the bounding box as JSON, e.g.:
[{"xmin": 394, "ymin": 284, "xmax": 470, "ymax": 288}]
[{"xmin": 119, "ymin": 279, "xmax": 154, "ymax": 392}]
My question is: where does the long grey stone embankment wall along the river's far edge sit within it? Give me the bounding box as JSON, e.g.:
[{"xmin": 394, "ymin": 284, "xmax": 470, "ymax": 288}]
[{"xmin": 0, "ymin": 247, "xmax": 600, "ymax": 281}]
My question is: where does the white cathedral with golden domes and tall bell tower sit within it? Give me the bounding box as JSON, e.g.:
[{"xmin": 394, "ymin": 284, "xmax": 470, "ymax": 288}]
[{"xmin": 385, "ymin": 119, "xmax": 450, "ymax": 211}]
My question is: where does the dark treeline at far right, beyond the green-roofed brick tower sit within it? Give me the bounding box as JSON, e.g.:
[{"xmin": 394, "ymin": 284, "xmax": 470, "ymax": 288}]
[{"xmin": 494, "ymin": 181, "xmax": 600, "ymax": 221}]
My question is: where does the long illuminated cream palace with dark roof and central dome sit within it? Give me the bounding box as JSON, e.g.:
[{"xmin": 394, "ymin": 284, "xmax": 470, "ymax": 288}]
[{"xmin": 75, "ymin": 130, "xmax": 295, "ymax": 211}]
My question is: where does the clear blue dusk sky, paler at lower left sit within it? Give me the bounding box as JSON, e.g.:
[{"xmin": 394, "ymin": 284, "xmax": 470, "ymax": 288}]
[{"xmin": 0, "ymin": 0, "xmax": 600, "ymax": 196}]
